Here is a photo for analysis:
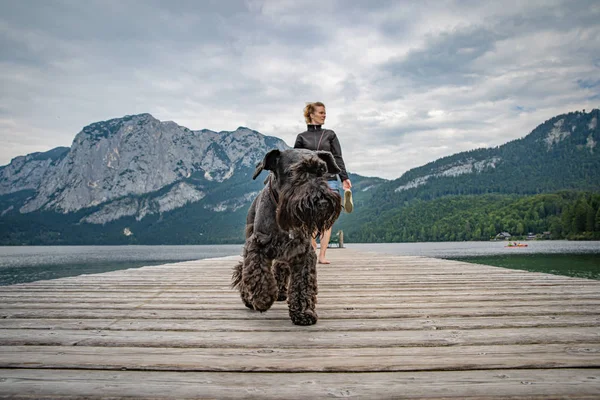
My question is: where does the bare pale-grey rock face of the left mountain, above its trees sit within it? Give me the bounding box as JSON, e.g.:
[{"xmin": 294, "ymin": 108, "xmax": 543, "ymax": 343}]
[{"xmin": 0, "ymin": 113, "xmax": 287, "ymax": 216}]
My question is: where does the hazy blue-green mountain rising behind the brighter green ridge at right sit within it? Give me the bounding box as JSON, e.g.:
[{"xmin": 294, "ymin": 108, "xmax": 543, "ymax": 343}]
[{"xmin": 339, "ymin": 109, "xmax": 600, "ymax": 241}]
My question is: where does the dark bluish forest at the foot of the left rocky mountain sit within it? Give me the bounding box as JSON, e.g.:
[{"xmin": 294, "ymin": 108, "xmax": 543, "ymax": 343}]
[{"xmin": 0, "ymin": 204, "xmax": 246, "ymax": 246}]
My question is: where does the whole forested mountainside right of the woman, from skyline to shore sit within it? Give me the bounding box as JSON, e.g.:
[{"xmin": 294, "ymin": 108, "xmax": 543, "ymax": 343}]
[{"xmin": 336, "ymin": 109, "xmax": 600, "ymax": 242}]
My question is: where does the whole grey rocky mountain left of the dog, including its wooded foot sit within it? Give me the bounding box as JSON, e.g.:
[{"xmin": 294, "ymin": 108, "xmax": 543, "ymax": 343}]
[{"xmin": 0, "ymin": 114, "xmax": 383, "ymax": 244}]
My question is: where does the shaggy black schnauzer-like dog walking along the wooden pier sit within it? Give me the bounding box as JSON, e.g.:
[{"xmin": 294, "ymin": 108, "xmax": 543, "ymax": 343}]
[{"xmin": 232, "ymin": 149, "xmax": 342, "ymax": 325}]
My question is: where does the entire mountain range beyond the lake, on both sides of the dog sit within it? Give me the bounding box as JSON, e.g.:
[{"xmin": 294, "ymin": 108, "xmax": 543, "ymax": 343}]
[{"xmin": 0, "ymin": 109, "xmax": 600, "ymax": 245}]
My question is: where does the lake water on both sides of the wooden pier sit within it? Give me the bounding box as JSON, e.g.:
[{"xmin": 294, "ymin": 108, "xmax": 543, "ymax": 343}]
[{"xmin": 0, "ymin": 241, "xmax": 600, "ymax": 285}]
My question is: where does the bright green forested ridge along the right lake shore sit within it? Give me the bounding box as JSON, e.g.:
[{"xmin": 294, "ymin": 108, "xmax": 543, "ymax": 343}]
[{"xmin": 341, "ymin": 191, "xmax": 600, "ymax": 243}]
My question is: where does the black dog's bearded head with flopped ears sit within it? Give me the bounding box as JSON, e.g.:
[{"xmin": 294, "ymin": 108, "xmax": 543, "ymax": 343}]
[{"xmin": 252, "ymin": 149, "xmax": 342, "ymax": 234}]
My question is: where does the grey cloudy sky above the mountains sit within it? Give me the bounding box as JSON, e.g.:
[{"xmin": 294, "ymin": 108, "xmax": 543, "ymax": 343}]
[{"xmin": 0, "ymin": 0, "xmax": 600, "ymax": 178}]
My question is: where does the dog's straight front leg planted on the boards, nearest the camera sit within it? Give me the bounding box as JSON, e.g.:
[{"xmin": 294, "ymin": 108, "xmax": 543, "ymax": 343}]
[{"xmin": 288, "ymin": 241, "xmax": 318, "ymax": 325}]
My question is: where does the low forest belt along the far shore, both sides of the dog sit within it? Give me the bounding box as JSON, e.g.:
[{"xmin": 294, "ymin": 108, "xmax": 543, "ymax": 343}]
[{"xmin": 0, "ymin": 191, "xmax": 600, "ymax": 245}]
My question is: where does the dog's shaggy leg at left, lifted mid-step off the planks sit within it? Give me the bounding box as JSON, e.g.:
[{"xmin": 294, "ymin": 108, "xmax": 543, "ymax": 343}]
[{"xmin": 242, "ymin": 233, "xmax": 278, "ymax": 312}]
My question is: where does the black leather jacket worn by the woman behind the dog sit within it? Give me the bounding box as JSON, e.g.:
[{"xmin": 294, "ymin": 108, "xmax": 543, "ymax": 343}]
[{"xmin": 294, "ymin": 125, "xmax": 348, "ymax": 182}]
